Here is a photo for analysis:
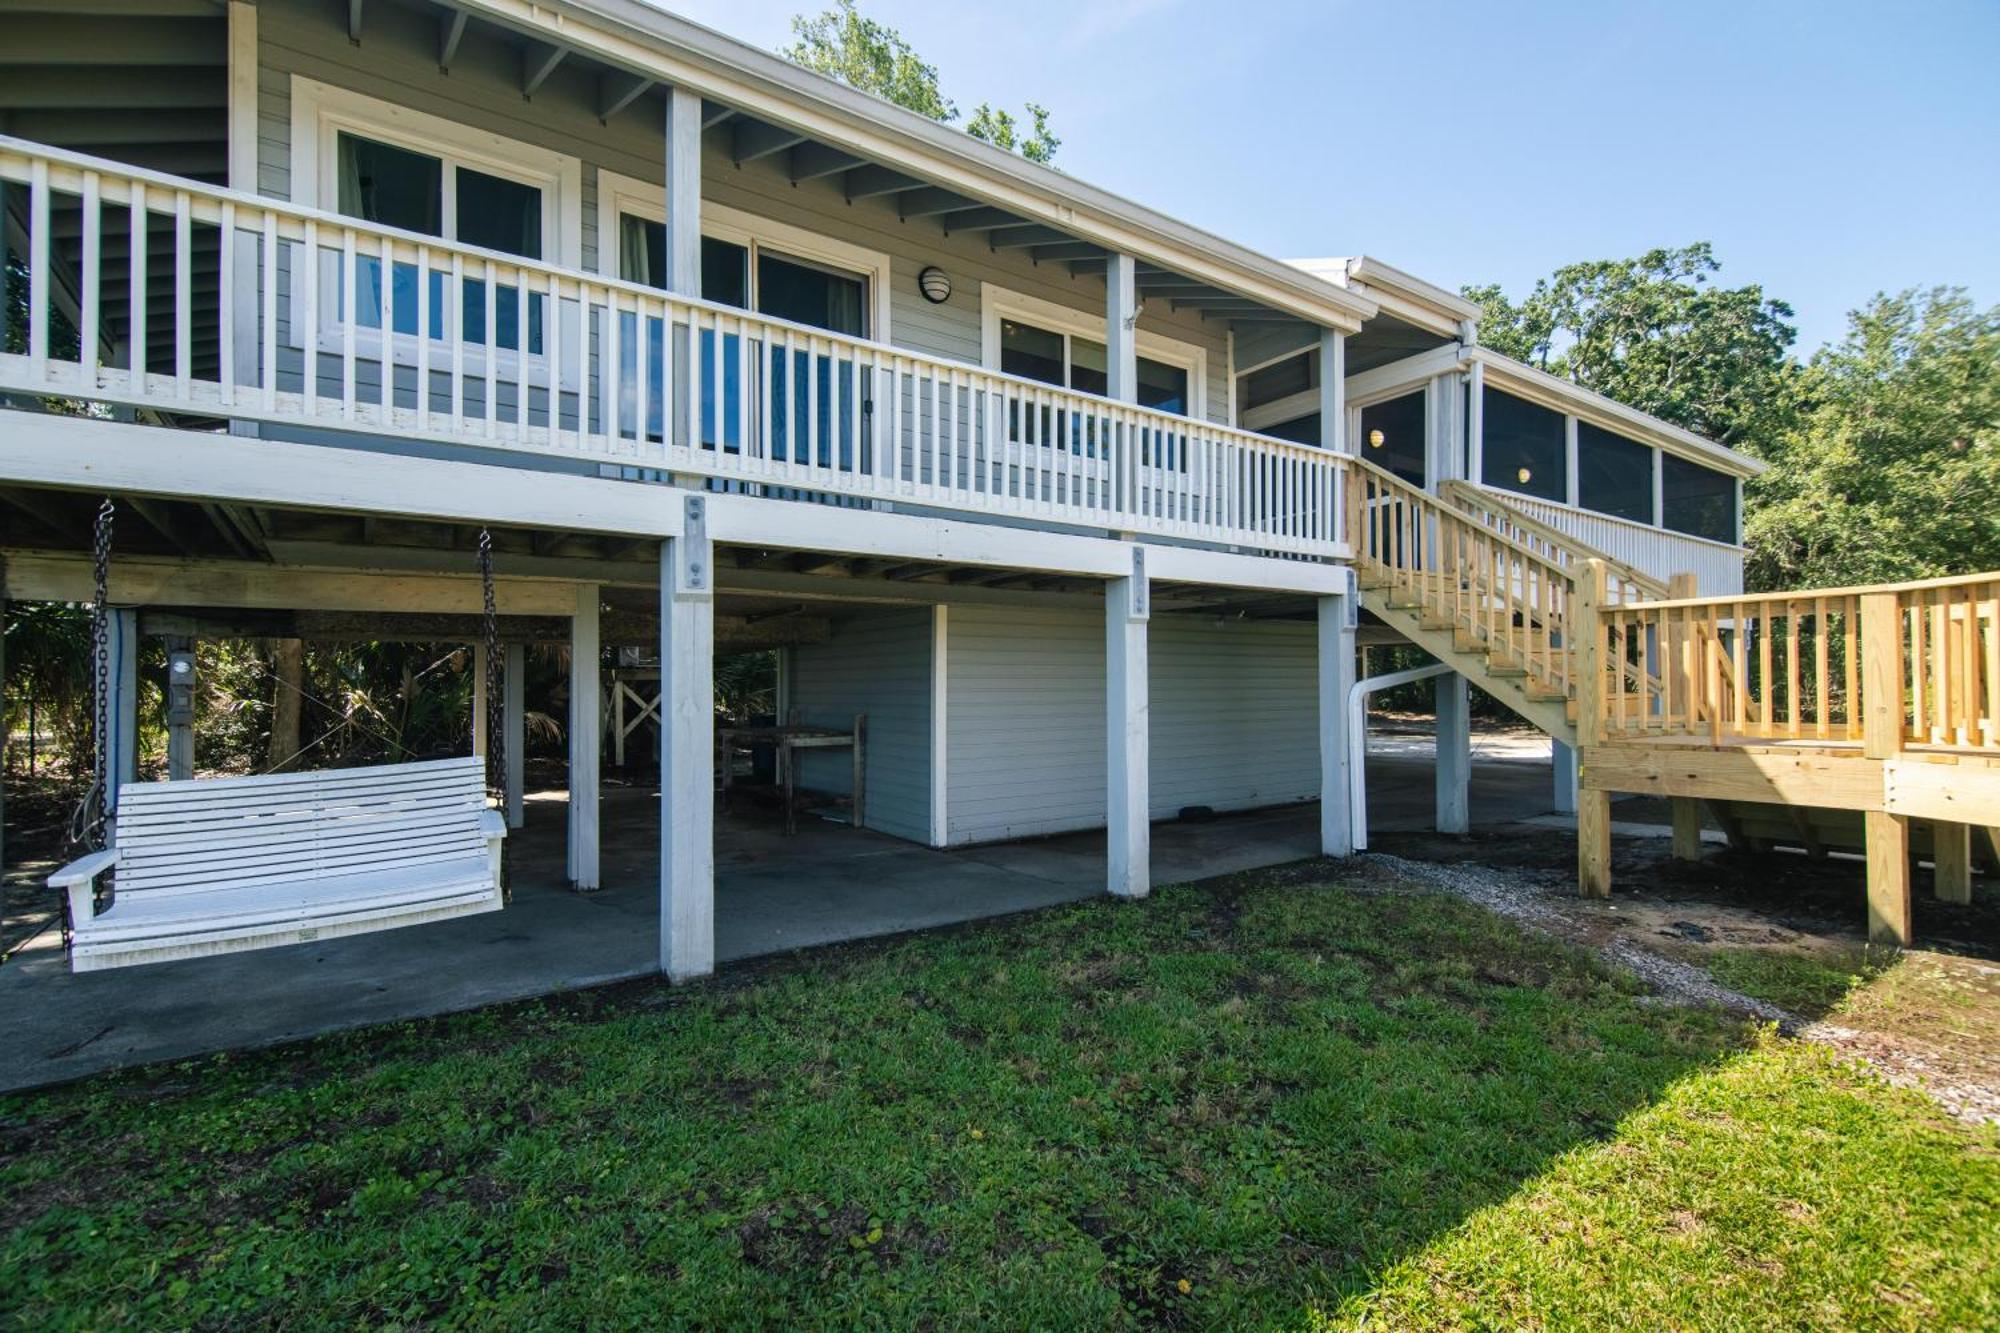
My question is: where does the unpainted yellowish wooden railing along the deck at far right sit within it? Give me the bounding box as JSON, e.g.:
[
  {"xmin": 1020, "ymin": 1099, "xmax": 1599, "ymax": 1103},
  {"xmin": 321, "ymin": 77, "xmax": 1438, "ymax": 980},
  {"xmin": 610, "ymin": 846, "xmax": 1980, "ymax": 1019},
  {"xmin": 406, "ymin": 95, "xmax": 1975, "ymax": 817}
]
[{"xmin": 1592, "ymin": 564, "xmax": 2000, "ymax": 753}]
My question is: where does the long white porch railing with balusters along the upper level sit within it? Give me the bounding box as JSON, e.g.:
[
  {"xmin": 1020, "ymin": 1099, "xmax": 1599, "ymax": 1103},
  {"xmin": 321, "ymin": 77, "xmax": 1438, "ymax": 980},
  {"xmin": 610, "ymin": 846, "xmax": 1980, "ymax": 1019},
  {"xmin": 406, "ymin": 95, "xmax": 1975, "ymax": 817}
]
[{"xmin": 0, "ymin": 138, "xmax": 1346, "ymax": 556}]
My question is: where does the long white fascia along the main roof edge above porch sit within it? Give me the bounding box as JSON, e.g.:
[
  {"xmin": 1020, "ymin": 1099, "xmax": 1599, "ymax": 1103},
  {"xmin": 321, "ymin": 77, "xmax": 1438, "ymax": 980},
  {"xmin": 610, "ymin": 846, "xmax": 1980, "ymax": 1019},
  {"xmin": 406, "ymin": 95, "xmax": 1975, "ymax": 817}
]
[{"xmin": 444, "ymin": 0, "xmax": 1376, "ymax": 332}]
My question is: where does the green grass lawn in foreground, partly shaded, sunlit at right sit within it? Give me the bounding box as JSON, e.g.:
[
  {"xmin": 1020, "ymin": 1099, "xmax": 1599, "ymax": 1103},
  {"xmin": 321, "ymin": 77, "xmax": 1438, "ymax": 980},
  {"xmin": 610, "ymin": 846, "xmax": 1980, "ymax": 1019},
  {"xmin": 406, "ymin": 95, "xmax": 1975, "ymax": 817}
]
[{"xmin": 0, "ymin": 875, "xmax": 2000, "ymax": 1329}]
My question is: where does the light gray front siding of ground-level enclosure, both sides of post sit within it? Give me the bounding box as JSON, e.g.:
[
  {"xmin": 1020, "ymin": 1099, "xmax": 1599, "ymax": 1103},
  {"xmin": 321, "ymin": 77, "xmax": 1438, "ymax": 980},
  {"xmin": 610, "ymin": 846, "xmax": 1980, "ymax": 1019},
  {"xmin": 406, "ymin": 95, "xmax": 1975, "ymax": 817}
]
[{"xmin": 944, "ymin": 606, "xmax": 1320, "ymax": 843}]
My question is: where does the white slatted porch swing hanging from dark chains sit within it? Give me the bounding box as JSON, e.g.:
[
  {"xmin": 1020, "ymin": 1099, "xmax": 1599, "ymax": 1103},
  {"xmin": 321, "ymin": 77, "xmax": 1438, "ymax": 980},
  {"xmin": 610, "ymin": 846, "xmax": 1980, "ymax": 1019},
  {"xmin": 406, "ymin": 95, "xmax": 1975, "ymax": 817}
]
[{"xmin": 48, "ymin": 500, "xmax": 506, "ymax": 973}]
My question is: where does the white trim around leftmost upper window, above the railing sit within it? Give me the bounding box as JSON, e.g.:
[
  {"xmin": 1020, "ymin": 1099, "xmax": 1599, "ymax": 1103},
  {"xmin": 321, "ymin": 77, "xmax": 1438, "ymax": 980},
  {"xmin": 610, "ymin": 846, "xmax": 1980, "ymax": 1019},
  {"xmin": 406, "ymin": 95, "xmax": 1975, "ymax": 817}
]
[{"xmin": 292, "ymin": 74, "xmax": 584, "ymax": 268}]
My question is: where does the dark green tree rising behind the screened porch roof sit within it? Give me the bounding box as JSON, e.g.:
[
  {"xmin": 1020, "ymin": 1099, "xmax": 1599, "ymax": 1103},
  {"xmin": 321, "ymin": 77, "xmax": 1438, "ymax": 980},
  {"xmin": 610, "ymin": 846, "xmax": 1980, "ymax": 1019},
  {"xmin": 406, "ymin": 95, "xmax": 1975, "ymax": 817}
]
[{"xmin": 1464, "ymin": 242, "xmax": 1798, "ymax": 452}]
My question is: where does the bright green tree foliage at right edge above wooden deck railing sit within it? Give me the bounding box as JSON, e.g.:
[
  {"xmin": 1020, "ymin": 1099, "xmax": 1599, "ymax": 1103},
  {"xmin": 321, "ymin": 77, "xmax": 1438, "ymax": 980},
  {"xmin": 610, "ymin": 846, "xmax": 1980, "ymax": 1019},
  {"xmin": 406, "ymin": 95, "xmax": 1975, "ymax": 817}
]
[{"xmin": 1746, "ymin": 288, "xmax": 2000, "ymax": 588}]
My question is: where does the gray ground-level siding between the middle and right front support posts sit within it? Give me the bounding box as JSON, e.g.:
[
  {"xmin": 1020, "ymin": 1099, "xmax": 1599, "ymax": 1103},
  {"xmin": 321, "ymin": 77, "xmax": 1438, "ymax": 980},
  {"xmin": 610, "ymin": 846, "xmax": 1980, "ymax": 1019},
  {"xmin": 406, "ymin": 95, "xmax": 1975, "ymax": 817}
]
[{"xmin": 1150, "ymin": 616, "xmax": 1320, "ymax": 819}]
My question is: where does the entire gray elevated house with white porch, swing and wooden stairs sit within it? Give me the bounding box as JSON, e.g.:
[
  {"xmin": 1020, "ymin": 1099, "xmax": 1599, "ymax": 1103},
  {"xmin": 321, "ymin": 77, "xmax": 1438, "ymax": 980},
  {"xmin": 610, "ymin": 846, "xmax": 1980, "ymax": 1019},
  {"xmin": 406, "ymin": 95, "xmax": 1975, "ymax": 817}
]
[{"xmin": 0, "ymin": 0, "xmax": 2000, "ymax": 1079}]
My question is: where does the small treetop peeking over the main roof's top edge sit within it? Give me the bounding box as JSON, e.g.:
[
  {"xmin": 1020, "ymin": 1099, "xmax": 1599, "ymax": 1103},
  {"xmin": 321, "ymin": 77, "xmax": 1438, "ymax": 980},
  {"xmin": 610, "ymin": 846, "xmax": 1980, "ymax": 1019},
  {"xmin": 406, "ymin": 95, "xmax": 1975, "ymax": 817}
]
[{"xmin": 780, "ymin": 0, "xmax": 1062, "ymax": 164}]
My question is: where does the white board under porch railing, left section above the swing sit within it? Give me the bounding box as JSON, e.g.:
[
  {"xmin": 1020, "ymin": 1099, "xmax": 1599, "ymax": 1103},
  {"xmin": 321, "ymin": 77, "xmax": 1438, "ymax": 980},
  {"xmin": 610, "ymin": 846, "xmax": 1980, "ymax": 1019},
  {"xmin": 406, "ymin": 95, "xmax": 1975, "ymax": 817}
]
[{"xmin": 0, "ymin": 412, "xmax": 680, "ymax": 536}]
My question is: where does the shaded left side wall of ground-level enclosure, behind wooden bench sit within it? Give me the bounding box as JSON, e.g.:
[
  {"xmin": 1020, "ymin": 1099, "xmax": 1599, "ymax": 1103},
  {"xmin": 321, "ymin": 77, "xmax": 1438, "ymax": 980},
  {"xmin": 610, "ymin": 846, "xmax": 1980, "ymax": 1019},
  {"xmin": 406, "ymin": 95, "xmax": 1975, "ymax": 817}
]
[{"xmin": 790, "ymin": 608, "xmax": 930, "ymax": 843}]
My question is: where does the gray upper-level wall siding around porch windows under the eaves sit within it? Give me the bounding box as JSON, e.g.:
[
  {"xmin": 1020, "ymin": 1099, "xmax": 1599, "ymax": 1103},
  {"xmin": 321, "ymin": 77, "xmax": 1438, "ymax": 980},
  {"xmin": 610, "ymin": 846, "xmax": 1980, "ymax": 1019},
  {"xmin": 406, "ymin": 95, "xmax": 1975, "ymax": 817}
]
[{"xmin": 258, "ymin": 0, "xmax": 1228, "ymax": 420}]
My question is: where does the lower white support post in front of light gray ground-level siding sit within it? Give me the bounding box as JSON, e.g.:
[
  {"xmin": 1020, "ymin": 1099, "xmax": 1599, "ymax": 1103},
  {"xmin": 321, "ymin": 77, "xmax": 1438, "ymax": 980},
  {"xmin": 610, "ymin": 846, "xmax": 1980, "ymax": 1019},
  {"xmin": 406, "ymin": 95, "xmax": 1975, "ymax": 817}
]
[{"xmin": 1104, "ymin": 546, "xmax": 1152, "ymax": 899}]
